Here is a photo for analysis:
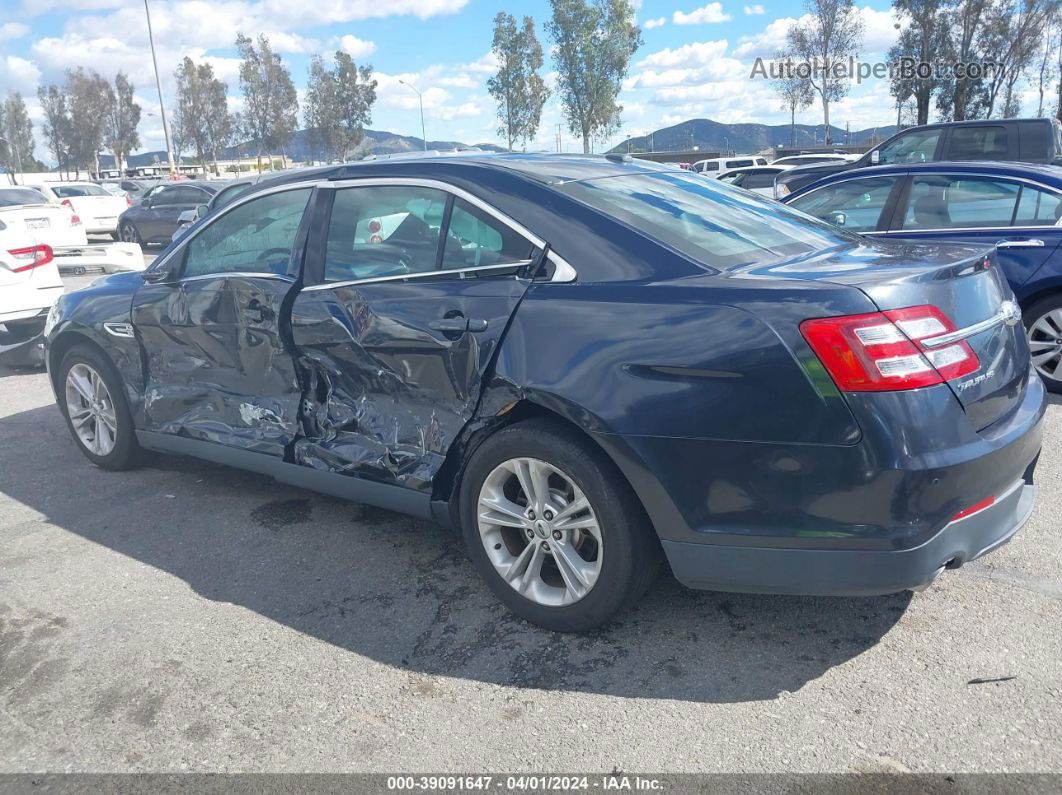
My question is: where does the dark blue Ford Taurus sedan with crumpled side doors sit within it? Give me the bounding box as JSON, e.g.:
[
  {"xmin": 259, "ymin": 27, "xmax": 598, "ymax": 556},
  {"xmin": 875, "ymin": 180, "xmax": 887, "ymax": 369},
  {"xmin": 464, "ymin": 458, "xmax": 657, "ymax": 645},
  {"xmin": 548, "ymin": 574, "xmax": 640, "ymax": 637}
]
[{"xmin": 48, "ymin": 155, "xmax": 1045, "ymax": 630}]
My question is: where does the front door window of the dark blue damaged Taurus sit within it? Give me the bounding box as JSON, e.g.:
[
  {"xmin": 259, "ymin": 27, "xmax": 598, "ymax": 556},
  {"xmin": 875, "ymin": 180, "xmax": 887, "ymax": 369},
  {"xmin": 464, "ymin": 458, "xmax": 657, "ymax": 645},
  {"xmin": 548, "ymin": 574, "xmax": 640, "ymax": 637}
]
[{"xmin": 184, "ymin": 188, "xmax": 311, "ymax": 276}]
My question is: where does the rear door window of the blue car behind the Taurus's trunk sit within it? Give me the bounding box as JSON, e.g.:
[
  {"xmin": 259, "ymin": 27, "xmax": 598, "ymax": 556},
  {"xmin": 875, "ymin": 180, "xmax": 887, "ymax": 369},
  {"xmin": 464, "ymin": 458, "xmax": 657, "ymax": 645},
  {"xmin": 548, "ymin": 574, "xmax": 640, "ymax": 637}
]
[{"xmin": 903, "ymin": 175, "xmax": 1021, "ymax": 229}]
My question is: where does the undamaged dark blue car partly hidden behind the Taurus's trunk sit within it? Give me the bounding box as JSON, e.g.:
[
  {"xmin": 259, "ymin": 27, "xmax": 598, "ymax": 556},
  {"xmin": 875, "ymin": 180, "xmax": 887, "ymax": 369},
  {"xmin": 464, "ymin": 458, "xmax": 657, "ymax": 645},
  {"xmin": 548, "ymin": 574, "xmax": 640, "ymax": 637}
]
[{"xmin": 784, "ymin": 162, "xmax": 1062, "ymax": 392}]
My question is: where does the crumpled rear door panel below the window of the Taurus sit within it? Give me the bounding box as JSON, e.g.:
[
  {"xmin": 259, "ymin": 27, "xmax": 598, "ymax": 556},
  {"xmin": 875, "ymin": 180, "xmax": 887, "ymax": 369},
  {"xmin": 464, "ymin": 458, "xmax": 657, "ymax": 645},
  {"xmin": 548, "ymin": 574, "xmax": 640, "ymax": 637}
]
[{"xmin": 291, "ymin": 278, "xmax": 528, "ymax": 491}]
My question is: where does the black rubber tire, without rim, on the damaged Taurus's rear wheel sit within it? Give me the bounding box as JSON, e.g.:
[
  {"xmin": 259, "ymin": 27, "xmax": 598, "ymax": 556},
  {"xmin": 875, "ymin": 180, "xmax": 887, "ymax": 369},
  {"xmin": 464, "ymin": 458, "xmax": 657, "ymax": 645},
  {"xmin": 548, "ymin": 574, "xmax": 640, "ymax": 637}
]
[{"xmin": 459, "ymin": 418, "xmax": 662, "ymax": 633}]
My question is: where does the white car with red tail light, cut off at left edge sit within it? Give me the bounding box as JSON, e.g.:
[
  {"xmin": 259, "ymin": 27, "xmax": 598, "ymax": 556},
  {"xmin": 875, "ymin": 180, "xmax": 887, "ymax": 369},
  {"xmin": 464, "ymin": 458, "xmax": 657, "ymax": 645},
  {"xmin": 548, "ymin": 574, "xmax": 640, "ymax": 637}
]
[{"xmin": 0, "ymin": 245, "xmax": 63, "ymax": 366}]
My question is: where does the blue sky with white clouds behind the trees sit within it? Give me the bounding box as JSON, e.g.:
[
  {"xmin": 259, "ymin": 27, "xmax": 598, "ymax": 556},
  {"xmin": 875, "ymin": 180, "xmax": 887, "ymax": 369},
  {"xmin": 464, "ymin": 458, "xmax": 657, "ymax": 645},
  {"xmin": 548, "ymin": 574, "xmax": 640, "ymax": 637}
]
[{"xmin": 0, "ymin": 0, "xmax": 964, "ymax": 159}]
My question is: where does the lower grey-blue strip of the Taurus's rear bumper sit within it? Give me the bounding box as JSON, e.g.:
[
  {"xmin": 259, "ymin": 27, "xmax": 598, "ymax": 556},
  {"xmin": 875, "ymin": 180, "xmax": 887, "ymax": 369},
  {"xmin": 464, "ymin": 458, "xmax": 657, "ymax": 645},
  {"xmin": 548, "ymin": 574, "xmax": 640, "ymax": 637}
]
[{"xmin": 663, "ymin": 480, "xmax": 1037, "ymax": 597}]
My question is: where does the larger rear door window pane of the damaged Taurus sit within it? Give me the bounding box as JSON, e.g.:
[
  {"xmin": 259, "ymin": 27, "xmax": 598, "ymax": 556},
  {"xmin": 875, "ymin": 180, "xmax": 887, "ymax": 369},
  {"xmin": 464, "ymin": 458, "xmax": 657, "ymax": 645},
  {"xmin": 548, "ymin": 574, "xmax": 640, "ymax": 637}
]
[{"xmin": 324, "ymin": 186, "xmax": 446, "ymax": 281}]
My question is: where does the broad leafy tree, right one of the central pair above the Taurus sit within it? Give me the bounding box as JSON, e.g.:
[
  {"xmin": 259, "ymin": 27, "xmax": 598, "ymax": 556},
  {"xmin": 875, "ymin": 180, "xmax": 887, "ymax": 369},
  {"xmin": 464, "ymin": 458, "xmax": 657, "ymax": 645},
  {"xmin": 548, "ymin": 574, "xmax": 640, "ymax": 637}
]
[{"xmin": 546, "ymin": 0, "xmax": 641, "ymax": 153}]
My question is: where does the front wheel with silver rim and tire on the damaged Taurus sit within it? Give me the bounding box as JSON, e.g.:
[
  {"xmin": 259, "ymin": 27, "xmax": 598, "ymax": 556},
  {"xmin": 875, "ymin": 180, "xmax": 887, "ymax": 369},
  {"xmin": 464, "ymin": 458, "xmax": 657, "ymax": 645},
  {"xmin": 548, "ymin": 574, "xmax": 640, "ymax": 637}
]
[{"xmin": 58, "ymin": 345, "xmax": 143, "ymax": 470}]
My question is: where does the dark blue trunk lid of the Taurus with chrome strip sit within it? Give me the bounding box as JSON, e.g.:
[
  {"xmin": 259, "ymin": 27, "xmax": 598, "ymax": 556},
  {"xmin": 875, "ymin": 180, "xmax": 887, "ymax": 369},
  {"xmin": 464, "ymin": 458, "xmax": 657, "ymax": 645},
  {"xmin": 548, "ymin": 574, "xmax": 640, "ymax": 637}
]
[{"xmin": 732, "ymin": 240, "xmax": 1030, "ymax": 430}]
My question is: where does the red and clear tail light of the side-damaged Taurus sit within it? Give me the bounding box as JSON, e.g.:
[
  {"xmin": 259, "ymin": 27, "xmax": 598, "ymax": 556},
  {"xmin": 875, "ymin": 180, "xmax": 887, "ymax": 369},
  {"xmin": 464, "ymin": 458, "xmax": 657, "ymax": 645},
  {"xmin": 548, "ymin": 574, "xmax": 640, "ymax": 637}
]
[{"xmin": 800, "ymin": 306, "xmax": 980, "ymax": 392}]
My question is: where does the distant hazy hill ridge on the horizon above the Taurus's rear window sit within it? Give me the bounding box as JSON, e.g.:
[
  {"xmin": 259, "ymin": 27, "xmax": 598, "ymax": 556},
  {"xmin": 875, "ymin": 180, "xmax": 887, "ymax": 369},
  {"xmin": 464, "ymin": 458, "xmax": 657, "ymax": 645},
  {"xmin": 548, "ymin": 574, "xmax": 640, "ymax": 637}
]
[{"xmin": 612, "ymin": 119, "xmax": 896, "ymax": 154}]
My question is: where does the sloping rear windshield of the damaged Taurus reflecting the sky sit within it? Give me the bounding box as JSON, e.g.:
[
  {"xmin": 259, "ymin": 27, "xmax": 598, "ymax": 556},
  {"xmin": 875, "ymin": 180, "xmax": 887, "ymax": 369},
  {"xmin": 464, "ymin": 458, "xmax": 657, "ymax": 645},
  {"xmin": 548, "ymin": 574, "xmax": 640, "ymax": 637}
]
[{"xmin": 554, "ymin": 172, "xmax": 859, "ymax": 269}]
